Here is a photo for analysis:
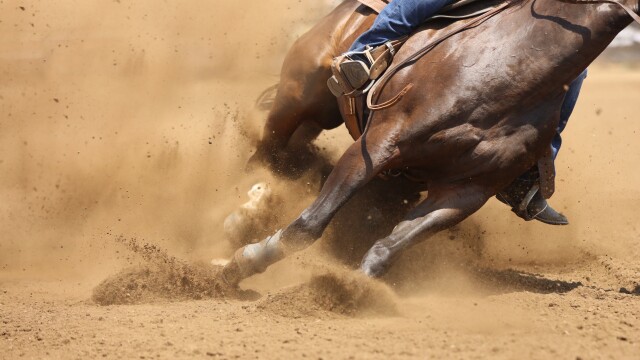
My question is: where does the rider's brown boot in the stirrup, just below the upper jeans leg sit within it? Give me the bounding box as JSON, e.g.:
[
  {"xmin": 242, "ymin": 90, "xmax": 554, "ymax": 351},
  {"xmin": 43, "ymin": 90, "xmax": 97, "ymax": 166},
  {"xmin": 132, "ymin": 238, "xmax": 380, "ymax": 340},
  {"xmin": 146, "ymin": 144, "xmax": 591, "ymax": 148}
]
[{"xmin": 327, "ymin": 38, "xmax": 406, "ymax": 97}]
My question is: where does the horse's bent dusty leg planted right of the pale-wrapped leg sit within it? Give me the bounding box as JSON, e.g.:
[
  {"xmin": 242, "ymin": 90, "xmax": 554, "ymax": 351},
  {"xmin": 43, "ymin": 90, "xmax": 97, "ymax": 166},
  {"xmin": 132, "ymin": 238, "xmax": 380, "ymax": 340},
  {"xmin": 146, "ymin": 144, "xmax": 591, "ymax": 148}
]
[{"xmin": 361, "ymin": 185, "xmax": 492, "ymax": 277}]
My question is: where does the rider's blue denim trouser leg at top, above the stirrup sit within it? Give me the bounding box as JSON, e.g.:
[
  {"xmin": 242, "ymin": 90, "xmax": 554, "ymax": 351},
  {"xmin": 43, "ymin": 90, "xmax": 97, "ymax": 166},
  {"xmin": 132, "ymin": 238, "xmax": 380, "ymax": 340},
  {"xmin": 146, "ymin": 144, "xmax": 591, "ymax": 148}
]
[{"xmin": 349, "ymin": 0, "xmax": 453, "ymax": 51}]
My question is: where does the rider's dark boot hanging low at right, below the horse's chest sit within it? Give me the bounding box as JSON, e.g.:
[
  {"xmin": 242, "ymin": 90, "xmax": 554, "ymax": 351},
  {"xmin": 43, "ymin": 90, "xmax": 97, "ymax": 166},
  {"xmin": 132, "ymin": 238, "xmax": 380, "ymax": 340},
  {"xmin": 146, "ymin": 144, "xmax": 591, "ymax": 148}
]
[{"xmin": 496, "ymin": 168, "xmax": 569, "ymax": 225}]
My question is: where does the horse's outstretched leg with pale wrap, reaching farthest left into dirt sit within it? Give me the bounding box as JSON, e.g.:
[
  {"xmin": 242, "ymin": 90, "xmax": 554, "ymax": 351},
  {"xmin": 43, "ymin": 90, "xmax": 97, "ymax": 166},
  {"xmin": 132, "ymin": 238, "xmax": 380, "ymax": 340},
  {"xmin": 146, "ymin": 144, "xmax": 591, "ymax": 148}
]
[{"xmin": 223, "ymin": 136, "xmax": 397, "ymax": 285}]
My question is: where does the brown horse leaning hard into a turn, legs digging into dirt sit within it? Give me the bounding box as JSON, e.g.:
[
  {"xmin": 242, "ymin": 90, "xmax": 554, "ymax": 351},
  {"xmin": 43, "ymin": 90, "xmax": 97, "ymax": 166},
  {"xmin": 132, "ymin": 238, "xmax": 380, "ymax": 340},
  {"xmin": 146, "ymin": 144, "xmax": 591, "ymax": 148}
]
[{"xmin": 223, "ymin": 0, "xmax": 639, "ymax": 284}]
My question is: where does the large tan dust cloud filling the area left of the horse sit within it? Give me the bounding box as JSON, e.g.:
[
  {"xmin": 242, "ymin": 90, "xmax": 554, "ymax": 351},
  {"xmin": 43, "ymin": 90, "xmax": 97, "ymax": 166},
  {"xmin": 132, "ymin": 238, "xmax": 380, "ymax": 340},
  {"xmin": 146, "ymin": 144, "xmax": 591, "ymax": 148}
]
[{"xmin": 0, "ymin": 0, "xmax": 338, "ymax": 282}]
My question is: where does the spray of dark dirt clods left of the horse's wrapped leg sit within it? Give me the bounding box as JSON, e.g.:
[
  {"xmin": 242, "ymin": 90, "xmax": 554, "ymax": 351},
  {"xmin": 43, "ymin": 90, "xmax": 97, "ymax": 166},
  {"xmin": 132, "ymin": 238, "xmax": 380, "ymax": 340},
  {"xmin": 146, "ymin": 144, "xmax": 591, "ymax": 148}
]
[{"xmin": 92, "ymin": 237, "xmax": 251, "ymax": 305}]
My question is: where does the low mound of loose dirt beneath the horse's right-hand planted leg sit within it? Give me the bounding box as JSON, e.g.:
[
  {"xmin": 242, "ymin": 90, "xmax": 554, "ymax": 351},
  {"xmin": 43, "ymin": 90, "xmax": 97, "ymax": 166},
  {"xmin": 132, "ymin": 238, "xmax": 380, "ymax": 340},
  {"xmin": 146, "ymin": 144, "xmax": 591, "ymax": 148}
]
[{"xmin": 257, "ymin": 272, "xmax": 398, "ymax": 318}]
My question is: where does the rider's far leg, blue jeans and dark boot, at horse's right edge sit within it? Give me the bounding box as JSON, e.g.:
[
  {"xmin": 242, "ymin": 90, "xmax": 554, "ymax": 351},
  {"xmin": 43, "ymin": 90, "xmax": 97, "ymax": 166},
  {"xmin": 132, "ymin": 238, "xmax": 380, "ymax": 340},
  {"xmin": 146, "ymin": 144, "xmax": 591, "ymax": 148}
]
[{"xmin": 497, "ymin": 70, "xmax": 587, "ymax": 225}]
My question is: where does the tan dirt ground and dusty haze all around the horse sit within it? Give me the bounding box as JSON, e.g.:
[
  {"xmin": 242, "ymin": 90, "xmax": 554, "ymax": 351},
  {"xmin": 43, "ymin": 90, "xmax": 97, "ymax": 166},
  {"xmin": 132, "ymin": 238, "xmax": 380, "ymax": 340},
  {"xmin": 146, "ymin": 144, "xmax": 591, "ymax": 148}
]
[{"xmin": 0, "ymin": 0, "xmax": 640, "ymax": 359}]
